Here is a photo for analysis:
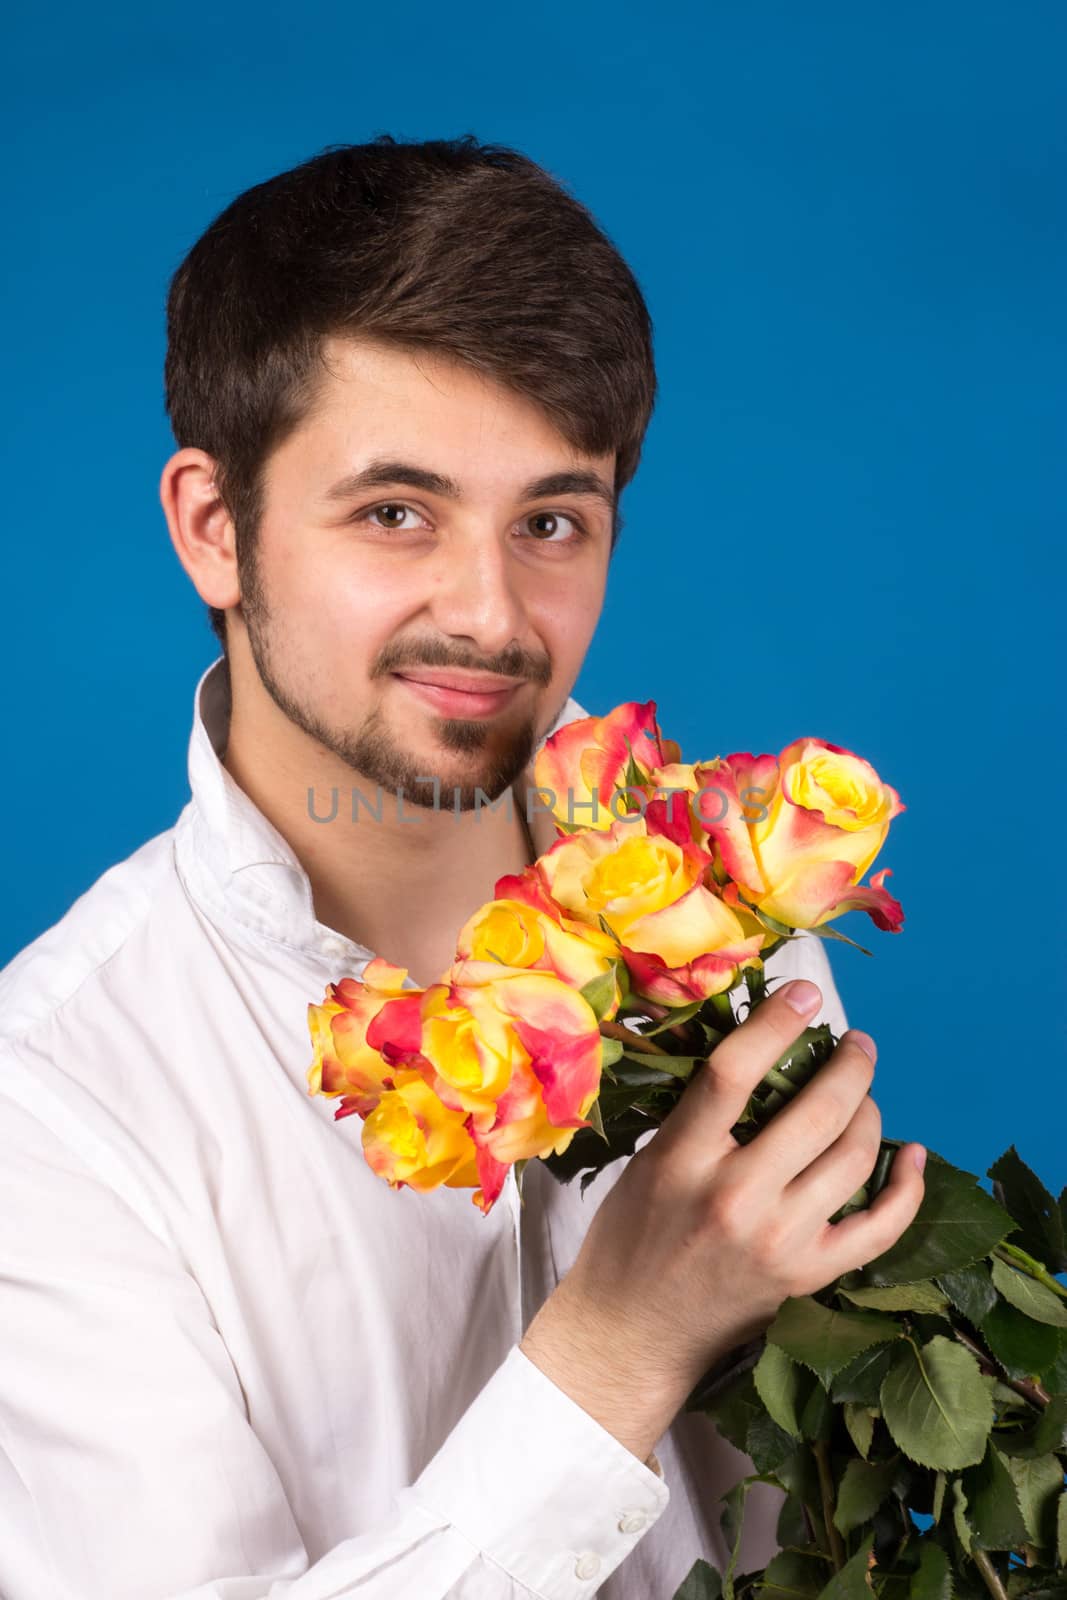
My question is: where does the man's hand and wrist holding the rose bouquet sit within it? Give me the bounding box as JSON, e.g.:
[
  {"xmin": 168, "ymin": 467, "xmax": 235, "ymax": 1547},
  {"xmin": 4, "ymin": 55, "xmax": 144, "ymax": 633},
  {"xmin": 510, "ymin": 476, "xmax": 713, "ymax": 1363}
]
[{"xmin": 520, "ymin": 979, "xmax": 923, "ymax": 1461}]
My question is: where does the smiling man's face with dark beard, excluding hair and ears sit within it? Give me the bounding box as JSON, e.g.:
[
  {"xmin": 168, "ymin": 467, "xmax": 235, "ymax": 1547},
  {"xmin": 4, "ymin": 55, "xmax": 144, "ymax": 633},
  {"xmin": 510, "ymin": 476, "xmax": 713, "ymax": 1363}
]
[{"xmin": 229, "ymin": 339, "xmax": 614, "ymax": 810}]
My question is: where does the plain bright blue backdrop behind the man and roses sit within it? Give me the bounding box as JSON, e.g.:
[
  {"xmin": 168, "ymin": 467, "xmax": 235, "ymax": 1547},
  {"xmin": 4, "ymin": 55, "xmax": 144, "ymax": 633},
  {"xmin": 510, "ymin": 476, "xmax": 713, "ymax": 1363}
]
[{"xmin": 0, "ymin": 0, "xmax": 1067, "ymax": 1192}]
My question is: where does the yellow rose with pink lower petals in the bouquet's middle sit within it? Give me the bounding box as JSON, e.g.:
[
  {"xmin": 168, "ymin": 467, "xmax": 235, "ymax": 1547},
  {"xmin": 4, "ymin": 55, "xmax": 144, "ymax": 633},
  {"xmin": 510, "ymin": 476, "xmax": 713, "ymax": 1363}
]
[{"xmin": 526, "ymin": 812, "xmax": 766, "ymax": 1005}]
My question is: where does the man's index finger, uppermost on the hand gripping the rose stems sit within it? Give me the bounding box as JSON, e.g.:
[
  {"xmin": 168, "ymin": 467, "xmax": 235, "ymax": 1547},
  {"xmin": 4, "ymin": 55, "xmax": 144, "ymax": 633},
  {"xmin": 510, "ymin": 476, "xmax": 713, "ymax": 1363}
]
[{"xmin": 653, "ymin": 979, "xmax": 822, "ymax": 1165}]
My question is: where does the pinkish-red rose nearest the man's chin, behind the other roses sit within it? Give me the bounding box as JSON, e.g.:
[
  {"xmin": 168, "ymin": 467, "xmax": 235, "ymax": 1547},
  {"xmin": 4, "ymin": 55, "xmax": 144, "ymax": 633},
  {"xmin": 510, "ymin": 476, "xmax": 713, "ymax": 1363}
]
[{"xmin": 534, "ymin": 701, "xmax": 680, "ymax": 829}]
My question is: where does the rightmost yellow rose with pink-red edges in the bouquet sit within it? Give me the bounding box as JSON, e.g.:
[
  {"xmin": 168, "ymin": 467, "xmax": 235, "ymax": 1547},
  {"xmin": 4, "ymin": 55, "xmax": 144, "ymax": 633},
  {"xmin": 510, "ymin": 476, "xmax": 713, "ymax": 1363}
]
[{"xmin": 694, "ymin": 739, "xmax": 904, "ymax": 933}]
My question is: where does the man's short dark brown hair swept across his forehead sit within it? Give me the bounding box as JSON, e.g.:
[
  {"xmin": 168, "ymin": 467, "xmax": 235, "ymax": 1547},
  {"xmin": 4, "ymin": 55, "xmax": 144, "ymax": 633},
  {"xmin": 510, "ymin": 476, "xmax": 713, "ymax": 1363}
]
[{"xmin": 163, "ymin": 133, "xmax": 656, "ymax": 651}]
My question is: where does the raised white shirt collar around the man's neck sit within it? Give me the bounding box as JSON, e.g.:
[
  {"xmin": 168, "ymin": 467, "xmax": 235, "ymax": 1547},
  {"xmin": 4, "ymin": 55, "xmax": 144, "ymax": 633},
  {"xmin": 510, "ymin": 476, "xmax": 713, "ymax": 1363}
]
[{"xmin": 174, "ymin": 656, "xmax": 589, "ymax": 960}]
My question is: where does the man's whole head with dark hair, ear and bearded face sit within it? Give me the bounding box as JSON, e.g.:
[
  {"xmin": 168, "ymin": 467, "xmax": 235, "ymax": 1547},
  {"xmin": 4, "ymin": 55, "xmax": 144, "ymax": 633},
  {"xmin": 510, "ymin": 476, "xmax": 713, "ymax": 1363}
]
[{"xmin": 162, "ymin": 134, "xmax": 656, "ymax": 806}]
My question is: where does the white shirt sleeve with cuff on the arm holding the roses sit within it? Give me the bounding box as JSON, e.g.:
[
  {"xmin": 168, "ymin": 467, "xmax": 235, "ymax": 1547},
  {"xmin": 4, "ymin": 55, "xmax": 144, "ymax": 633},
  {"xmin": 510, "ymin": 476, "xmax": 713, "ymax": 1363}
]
[{"xmin": 0, "ymin": 1090, "xmax": 669, "ymax": 1600}]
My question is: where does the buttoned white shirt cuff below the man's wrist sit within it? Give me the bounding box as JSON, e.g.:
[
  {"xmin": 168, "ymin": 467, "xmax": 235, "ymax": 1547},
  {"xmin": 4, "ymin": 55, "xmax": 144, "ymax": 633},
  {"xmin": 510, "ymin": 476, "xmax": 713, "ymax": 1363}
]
[{"xmin": 406, "ymin": 1344, "xmax": 670, "ymax": 1600}]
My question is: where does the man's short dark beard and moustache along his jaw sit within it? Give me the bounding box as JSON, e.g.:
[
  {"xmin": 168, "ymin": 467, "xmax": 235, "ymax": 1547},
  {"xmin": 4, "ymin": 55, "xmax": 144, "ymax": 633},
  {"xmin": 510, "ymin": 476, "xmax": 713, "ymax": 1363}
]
[{"xmin": 238, "ymin": 549, "xmax": 561, "ymax": 814}]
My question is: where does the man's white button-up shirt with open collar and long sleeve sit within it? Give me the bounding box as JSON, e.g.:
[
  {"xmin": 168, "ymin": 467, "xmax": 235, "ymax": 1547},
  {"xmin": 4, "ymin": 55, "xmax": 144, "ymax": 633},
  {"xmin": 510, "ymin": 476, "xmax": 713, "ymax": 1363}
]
[{"xmin": 0, "ymin": 658, "xmax": 846, "ymax": 1600}]
